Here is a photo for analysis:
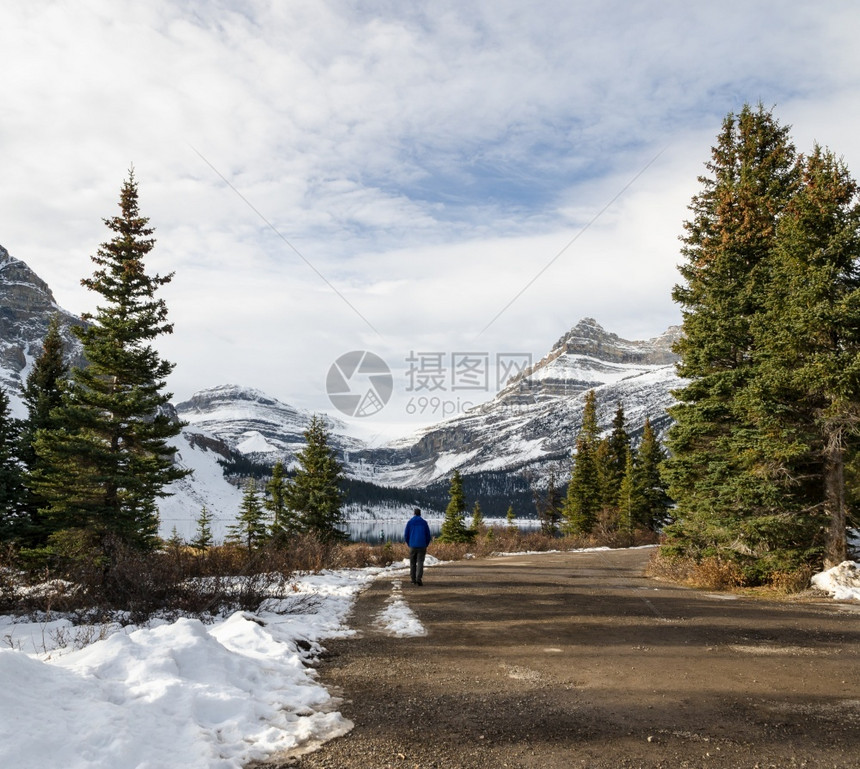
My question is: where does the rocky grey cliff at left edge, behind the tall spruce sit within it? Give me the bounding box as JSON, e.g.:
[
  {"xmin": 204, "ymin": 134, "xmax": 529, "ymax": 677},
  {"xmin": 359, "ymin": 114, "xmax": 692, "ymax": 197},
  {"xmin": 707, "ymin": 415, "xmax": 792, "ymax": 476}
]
[{"xmin": 0, "ymin": 246, "xmax": 82, "ymax": 416}]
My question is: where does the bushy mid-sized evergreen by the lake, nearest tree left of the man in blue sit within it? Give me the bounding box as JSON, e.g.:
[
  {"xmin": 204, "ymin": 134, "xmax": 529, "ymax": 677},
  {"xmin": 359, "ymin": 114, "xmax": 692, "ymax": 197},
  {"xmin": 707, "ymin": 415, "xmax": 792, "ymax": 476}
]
[{"xmin": 286, "ymin": 415, "xmax": 347, "ymax": 542}]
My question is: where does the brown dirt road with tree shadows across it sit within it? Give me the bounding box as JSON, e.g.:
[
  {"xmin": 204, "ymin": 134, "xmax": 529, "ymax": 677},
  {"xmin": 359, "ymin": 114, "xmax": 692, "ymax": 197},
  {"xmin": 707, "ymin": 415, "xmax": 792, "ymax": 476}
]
[{"xmin": 266, "ymin": 550, "xmax": 860, "ymax": 769}]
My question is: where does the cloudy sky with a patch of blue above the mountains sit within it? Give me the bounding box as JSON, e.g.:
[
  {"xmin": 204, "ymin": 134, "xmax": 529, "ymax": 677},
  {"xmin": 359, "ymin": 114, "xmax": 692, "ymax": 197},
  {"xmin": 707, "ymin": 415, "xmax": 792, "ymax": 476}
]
[{"xmin": 0, "ymin": 0, "xmax": 860, "ymax": 437}]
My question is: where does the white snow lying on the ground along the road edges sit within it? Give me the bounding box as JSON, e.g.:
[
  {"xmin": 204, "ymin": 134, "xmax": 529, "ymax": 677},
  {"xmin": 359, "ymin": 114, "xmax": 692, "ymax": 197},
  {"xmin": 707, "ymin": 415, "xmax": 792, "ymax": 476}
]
[{"xmin": 0, "ymin": 551, "xmax": 860, "ymax": 769}]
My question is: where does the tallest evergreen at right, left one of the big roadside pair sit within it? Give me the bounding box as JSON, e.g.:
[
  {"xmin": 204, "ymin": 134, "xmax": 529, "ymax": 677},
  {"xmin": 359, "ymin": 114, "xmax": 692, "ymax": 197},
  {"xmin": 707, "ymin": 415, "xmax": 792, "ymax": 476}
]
[{"xmin": 666, "ymin": 106, "xmax": 797, "ymax": 557}]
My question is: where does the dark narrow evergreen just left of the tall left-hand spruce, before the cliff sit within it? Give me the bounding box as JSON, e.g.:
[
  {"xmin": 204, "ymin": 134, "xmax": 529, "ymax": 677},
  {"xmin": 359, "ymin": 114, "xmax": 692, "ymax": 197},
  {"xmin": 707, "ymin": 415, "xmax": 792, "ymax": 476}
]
[{"xmin": 20, "ymin": 315, "xmax": 69, "ymax": 547}]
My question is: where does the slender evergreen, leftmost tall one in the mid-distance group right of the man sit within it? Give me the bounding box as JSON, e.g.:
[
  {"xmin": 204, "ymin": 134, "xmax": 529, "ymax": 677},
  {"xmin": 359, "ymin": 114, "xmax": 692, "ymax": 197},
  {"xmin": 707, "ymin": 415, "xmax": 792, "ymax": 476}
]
[{"xmin": 562, "ymin": 390, "xmax": 602, "ymax": 535}]
